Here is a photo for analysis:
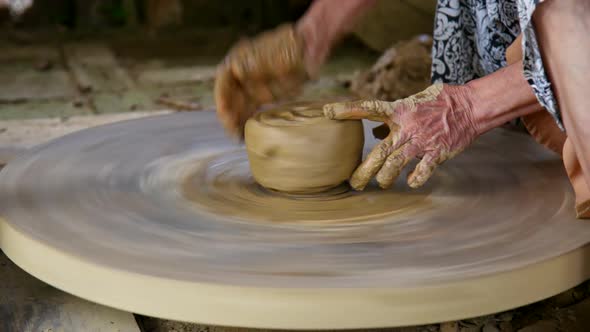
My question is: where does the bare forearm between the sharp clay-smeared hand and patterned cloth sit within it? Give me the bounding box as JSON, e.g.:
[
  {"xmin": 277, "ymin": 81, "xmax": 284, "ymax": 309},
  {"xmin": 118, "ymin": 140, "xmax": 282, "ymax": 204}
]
[{"xmin": 467, "ymin": 62, "xmax": 543, "ymax": 134}]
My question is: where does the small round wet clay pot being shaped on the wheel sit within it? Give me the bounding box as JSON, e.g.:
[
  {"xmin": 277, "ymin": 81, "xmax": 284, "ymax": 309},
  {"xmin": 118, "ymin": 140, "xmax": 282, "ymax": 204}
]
[{"xmin": 245, "ymin": 104, "xmax": 364, "ymax": 194}]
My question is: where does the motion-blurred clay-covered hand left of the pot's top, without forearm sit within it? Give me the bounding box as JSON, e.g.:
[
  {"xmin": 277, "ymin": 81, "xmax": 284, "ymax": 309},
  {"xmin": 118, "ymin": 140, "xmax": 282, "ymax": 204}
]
[{"xmin": 215, "ymin": 24, "xmax": 308, "ymax": 138}]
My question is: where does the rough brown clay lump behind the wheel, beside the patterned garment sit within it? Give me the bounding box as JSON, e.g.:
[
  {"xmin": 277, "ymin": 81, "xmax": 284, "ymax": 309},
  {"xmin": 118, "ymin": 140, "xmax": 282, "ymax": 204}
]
[{"xmin": 350, "ymin": 35, "xmax": 432, "ymax": 101}]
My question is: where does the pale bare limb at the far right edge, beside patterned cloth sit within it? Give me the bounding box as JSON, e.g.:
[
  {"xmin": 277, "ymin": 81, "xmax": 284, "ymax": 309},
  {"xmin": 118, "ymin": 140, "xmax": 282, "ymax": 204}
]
[{"xmin": 533, "ymin": 0, "xmax": 590, "ymax": 192}]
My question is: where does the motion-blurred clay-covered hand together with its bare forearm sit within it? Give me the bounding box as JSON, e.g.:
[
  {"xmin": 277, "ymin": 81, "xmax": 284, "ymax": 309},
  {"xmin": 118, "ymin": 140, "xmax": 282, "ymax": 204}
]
[{"xmin": 215, "ymin": 0, "xmax": 375, "ymax": 138}]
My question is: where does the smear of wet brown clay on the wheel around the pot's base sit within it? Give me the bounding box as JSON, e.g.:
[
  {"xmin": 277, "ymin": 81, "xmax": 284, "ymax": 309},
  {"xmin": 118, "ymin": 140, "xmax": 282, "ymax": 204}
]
[{"xmin": 179, "ymin": 151, "xmax": 433, "ymax": 226}]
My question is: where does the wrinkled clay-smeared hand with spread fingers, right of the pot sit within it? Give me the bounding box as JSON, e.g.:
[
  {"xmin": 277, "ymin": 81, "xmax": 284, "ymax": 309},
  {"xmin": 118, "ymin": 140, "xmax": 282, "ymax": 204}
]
[{"xmin": 324, "ymin": 84, "xmax": 479, "ymax": 190}]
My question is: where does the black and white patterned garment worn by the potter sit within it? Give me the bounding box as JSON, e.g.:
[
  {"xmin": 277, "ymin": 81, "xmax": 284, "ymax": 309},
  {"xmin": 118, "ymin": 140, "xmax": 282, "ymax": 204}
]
[{"xmin": 432, "ymin": 0, "xmax": 563, "ymax": 130}]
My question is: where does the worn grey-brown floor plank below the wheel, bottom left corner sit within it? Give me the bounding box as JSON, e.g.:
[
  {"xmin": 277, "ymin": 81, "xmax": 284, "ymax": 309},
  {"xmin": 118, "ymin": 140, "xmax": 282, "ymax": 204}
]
[{"xmin": 0, "ymin": 251, "xmax": 140, "ymax": 332}]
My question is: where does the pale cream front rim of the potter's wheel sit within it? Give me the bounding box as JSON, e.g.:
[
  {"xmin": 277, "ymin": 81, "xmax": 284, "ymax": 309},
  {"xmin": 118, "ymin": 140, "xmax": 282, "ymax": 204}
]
[{"xmin": 0, "ymin": 218, "xmax": 590, "ymax": 329}]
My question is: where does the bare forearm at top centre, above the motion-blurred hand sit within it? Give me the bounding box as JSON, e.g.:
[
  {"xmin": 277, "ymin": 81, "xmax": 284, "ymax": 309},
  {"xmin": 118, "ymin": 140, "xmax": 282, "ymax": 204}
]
[{"xmin": 296, "ymin": 0, "xmax": 376, "ymax": 72}]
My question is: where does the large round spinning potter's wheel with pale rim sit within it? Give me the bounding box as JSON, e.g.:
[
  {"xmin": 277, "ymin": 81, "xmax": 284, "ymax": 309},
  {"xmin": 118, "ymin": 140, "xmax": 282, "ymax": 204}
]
[{"xmin": 0, "ymin": 112, "xmax": 590, "ymax": 328}]
